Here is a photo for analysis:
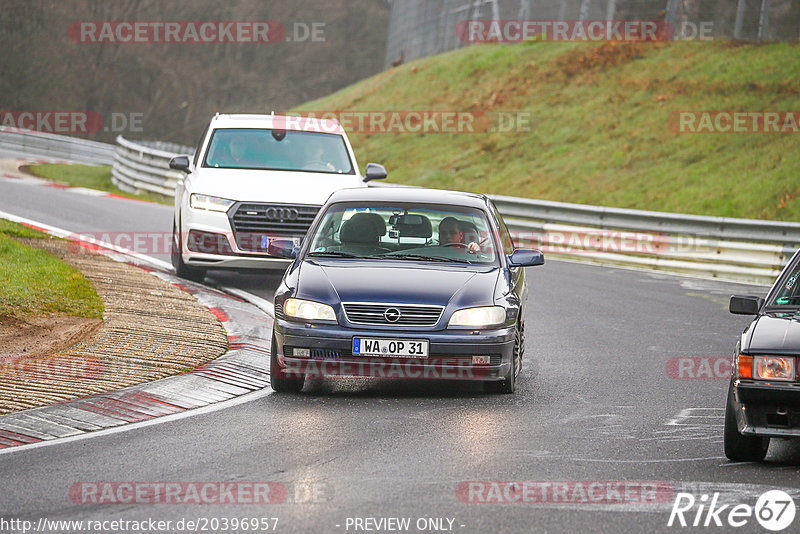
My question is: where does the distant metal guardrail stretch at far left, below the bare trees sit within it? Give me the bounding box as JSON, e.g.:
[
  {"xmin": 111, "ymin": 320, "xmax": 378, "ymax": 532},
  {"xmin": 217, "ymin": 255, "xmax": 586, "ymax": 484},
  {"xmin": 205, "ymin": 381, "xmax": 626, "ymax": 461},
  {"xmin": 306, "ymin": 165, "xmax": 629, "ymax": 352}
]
[{"xmin": 0, "ymin": 126, "xmax": 114, "ymax": 165}]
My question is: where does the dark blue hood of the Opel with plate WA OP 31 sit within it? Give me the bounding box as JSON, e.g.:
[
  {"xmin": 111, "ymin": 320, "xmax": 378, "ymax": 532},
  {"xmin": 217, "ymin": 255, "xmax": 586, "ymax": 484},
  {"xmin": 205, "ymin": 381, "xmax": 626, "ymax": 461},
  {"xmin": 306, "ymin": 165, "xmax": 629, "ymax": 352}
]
[{"xmin": 297, "ymin": 260, "xmax": 499, "ymax": 307}]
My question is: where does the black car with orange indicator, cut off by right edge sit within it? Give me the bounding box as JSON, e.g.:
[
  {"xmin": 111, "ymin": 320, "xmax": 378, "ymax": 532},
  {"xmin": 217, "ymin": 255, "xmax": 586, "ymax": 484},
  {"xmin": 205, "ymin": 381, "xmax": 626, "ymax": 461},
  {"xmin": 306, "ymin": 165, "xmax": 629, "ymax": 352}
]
[{"xmin": 725, "ymin": 251, "xmax": 800, "ymax": 461}]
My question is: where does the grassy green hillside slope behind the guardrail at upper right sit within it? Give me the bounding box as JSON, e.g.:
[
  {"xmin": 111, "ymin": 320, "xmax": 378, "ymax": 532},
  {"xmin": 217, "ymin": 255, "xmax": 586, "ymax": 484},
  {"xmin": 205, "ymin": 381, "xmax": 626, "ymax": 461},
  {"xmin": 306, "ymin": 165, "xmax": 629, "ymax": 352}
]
[{"xmin": 298, "ymin": 42, "xmax": 800, "ymax": 221}]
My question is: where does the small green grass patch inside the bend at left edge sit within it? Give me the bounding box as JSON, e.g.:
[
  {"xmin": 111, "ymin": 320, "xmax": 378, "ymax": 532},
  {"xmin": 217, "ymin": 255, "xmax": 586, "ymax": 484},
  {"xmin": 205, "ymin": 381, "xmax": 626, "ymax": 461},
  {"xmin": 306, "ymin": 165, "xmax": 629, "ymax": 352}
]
[{"xmin": 0, "ymin": 220, "xmax": 103, "ymax": 320}]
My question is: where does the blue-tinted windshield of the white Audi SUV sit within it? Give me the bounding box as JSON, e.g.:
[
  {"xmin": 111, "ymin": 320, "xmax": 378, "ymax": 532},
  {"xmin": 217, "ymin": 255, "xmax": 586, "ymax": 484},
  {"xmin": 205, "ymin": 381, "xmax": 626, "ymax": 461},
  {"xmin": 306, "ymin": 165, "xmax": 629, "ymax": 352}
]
[{"xmin": 203, "ymin": 128, "xmax": 355, "ymax": 174}]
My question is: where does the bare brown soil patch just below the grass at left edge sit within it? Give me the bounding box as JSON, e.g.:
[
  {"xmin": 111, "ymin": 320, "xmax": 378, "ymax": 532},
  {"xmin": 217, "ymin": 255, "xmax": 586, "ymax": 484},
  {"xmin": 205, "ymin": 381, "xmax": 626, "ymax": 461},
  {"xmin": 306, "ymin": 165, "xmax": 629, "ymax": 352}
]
[{"xmin": 0, "ymin": 315, "xmax": 103, "ymax": 358}]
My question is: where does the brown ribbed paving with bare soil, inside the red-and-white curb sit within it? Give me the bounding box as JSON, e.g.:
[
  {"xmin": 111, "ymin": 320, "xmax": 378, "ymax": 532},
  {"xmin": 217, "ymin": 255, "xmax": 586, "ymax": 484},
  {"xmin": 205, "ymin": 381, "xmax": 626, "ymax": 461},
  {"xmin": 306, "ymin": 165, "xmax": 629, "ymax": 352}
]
[{"xmin": 0, "ymin": 239, "xmax": 228, "ymax": 414}]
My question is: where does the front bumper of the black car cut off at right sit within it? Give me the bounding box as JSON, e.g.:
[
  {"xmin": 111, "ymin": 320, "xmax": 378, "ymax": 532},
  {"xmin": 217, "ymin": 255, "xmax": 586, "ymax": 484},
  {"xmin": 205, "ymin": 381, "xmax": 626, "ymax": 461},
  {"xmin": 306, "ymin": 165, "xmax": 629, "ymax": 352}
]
[{"xmin": 733, "ymin": 379, "xmax": 800, "ymax": 438}]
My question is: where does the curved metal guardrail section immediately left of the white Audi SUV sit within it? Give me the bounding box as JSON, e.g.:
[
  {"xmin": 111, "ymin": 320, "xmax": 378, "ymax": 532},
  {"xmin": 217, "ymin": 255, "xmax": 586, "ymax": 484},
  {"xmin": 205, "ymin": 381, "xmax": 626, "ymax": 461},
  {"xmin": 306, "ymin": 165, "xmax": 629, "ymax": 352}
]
[{"xmin": 111, "ymin": 135, "xmax": 194, "ymax": 197}]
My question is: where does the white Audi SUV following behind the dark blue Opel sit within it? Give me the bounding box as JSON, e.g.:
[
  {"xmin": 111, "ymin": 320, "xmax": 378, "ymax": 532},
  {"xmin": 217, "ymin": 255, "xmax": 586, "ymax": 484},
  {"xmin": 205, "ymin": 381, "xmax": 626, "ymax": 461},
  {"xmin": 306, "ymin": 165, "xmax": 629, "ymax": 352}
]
[{"xmin": 169, "ymin": 114, "xmax": 386, "ymax": 281}]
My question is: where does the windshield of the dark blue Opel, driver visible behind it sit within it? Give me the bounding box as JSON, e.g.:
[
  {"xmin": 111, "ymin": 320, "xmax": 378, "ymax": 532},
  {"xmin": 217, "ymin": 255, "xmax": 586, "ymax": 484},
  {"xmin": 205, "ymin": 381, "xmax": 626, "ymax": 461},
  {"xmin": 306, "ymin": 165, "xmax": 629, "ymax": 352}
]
[{"xmin": 307, "ymin": 203, "xmax": 497, "ymax": 264}]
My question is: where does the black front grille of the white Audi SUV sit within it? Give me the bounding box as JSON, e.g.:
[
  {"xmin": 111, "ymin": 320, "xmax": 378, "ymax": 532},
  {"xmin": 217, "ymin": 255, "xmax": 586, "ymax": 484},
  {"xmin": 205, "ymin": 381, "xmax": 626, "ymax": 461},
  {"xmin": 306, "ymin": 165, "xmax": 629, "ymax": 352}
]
[{"xmin": 229, "ymin": 203, "xmax": 320, "ymax": 252}]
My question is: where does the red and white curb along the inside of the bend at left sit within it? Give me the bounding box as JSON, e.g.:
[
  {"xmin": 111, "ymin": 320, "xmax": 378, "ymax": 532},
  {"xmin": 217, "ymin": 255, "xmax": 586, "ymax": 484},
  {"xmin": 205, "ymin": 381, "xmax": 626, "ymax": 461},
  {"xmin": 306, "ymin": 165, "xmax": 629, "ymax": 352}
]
[{"xmin": 0, "ymin": 212, "xmax": 273, "ymax": 453}]
